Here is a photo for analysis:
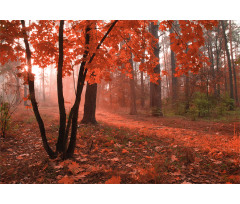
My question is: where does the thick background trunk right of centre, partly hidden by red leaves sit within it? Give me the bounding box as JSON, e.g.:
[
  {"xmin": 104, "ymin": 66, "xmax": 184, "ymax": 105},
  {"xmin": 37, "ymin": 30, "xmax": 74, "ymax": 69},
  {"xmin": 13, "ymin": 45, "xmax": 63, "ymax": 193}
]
[{"xmin": 150, "ymin": 23, "xmax": 163, "ymax": 116}]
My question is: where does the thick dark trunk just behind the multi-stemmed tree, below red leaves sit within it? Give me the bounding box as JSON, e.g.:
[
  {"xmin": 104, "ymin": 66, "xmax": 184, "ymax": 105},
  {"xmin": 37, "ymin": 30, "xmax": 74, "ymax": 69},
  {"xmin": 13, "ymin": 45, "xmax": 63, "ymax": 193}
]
[{"xmin": 81, "ymin": 83, "xmax": 97, "ymax": 124}]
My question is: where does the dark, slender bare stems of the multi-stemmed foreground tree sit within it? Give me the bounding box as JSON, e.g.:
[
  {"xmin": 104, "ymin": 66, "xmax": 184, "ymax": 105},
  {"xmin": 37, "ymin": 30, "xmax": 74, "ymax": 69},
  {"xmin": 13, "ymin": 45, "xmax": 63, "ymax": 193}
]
[{"xmin": 21, "ymin": 21, "xmax": 117, "ymax": 158}]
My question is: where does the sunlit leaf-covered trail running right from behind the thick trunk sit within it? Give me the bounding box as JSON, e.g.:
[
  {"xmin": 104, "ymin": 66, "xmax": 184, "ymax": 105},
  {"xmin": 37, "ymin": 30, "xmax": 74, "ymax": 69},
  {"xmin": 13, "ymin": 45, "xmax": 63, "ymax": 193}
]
[{"xmin": 96, "ymin": 111, "xmax": 240, "ymax": 155}]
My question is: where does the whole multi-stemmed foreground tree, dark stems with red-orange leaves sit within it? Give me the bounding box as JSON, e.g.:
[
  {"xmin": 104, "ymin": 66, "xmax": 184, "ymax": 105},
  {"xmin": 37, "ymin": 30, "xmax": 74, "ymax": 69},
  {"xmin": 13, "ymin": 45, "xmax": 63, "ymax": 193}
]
[{"xmin": 0, "ymin": 20, "xmax": 218, "ymax": 158}]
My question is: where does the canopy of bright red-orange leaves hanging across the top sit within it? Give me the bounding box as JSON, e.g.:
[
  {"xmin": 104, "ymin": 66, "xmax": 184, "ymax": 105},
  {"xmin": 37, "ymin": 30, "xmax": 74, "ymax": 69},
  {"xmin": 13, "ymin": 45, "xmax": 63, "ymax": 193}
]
[{"xmin": 0, "ymin": 20, "xmax": 217, "ymax": 82}]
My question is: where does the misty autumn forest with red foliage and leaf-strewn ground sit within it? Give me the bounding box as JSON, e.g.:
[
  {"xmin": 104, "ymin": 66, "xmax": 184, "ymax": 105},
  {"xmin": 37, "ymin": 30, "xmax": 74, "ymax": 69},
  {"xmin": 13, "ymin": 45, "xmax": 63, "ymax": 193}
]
[{"xmin": 0, "ymin": 20, "xmax": 240, "ymax": 184}]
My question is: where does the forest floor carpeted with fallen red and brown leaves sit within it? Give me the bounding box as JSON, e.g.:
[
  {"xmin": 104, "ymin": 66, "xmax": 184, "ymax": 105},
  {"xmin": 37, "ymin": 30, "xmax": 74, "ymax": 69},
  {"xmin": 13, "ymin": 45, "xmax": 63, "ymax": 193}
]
[{"xmin": 0, "ymin": 107, "xmax": 240, "ymax": 183}]
